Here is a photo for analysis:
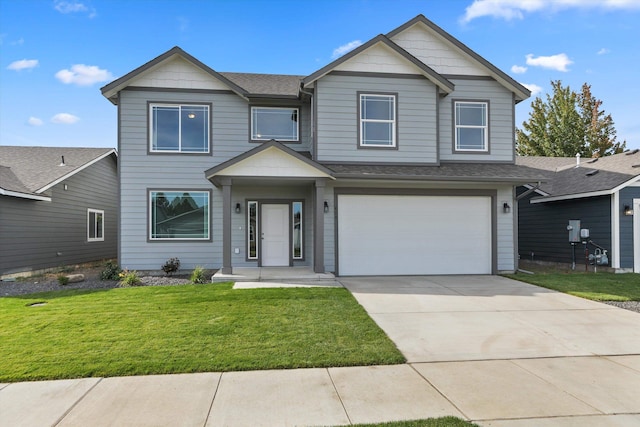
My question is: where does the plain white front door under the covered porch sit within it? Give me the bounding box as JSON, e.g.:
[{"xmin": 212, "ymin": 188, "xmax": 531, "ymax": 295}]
[{"xmin": 260, "ymin": 204, "xmax": 289, "ymax": 267}]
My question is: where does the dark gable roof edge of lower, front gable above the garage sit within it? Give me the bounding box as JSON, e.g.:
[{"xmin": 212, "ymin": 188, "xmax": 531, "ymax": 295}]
[{"xmin": 302, "ymin": 34, "xmax": 454, "ymax": 93}]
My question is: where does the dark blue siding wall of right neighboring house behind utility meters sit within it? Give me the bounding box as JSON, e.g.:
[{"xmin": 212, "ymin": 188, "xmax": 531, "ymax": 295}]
[{"xmin": 518, "ymin": 187, "xmax": 612, "ymax": 265}]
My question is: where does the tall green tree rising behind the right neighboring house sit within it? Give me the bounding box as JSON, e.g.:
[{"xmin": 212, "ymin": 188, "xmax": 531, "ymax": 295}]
[{"xmin": 516, "ymin": 80, "xmax": 626, "ymax": 157}]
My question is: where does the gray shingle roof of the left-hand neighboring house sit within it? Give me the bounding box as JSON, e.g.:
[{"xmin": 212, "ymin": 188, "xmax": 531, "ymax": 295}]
[{"xmin": 0, "ymin": 145, "xmax": 117, "ymax": 200}]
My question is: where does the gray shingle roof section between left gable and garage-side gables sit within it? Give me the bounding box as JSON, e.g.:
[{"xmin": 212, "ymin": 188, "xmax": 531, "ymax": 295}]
[{"xmin": 220, "ymin": 73, "xmax": 304, "ymax": 98}]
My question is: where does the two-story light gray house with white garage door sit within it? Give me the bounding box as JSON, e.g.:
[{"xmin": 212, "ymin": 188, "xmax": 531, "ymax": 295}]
[{"xmin": 102, "ymin": 15, "xmax": 543, "ymax": 275}]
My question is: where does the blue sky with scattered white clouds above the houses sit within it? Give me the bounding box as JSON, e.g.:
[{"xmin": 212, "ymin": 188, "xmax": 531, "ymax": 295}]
[{"xmin": 0, "ymin": 0, "xmax": 640, "ymax": 148}]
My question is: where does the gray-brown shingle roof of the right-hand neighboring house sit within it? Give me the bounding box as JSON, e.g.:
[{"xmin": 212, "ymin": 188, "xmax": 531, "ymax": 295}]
[{"xmin": 516, "ymin": 150, "xmax": 640, "ymax": 203}]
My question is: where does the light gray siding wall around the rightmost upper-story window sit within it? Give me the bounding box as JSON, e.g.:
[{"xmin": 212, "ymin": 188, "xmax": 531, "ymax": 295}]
[{"xmin": 439, "ymin": 78, "xmax": 515, "ymax": 163}]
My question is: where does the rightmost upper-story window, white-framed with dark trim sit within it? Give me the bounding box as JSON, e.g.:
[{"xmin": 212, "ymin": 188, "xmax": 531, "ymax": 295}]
[{"xmin": 454, "ymin": 101, "xmax": 489, "ymax": 151}]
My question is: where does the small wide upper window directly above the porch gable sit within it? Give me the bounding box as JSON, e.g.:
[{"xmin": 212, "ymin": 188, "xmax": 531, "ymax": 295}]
[{"xmin": 251, "ymin": 107, "xmax": 299, "ymax": 142}]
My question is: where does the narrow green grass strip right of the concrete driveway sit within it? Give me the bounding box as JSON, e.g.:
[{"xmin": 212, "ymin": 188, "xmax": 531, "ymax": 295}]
[{"xmin": 506, "ymin": 272, "xmax": 640, "ymax": 301}]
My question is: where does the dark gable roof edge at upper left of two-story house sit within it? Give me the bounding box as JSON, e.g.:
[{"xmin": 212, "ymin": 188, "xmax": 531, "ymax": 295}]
[{"xmin": 100, "ymin": 46, "xmax": 247, "ymax": 104}]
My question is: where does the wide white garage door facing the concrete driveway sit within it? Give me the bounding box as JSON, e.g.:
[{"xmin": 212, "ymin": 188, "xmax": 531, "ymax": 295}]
[{"xmin": 338, "ymin": 195, "xmax": 491, "ymax": 276}]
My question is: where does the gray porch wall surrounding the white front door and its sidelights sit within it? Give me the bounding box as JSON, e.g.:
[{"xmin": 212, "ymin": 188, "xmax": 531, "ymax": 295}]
[{"xmin": 231, "ymin": 185, "xmax": 313, "ymax": 267}]
